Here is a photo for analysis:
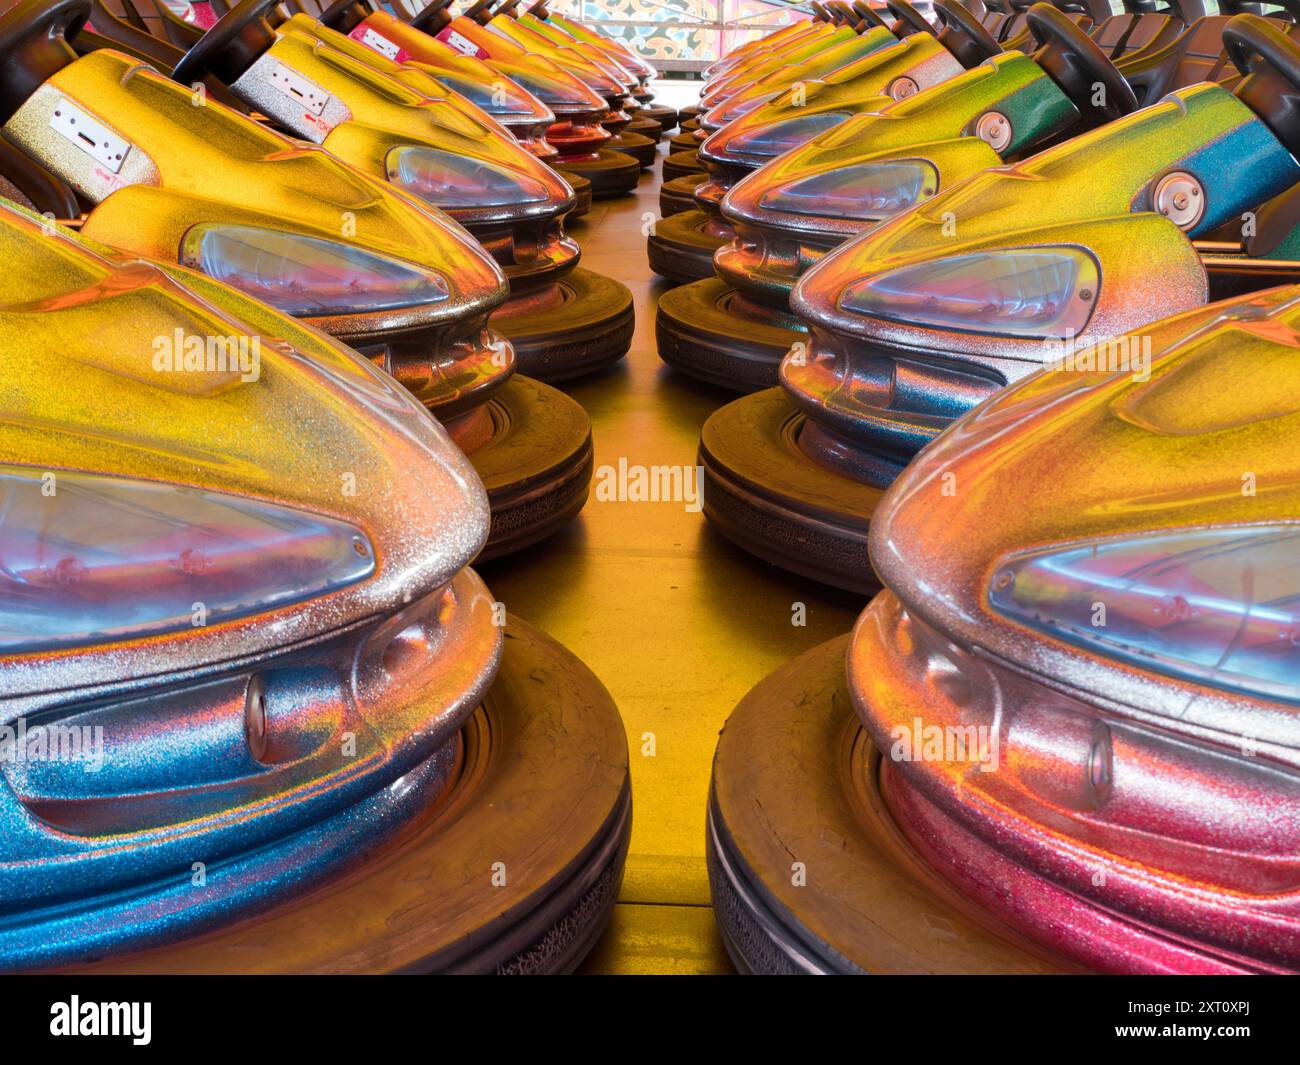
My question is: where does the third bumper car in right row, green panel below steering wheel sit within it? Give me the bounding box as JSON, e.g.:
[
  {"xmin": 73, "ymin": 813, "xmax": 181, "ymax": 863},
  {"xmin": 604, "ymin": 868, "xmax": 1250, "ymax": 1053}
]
[{"xmin": 655, "ymin": 0, "xmax": 1227, "ymax": 391}]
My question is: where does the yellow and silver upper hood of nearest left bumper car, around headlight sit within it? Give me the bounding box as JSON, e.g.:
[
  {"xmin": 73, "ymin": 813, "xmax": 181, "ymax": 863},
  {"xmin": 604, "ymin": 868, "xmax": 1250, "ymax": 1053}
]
[{"xmin": 0, "ymin": 202, "xmax": 488, "ymax": 717}]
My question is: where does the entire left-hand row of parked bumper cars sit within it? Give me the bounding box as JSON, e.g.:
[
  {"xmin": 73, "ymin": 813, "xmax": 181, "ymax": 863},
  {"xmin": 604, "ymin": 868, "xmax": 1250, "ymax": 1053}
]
[{"xmin": 0, "ymin": 0, "xmax": 677, "ymax": 973}]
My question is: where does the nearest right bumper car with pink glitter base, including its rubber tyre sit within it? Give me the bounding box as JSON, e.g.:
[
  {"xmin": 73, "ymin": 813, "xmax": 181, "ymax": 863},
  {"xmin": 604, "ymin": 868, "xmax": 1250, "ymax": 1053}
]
[{"xmin": 709, "ymin": 286, "xmax": 1300, "ymax": 974}]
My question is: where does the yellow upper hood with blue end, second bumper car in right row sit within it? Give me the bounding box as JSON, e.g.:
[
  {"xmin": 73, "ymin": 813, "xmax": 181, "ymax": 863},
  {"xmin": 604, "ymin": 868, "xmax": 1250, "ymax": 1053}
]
[{"xmin": 790, "ymin": 85, "xmax": 1300, "ymax": 371}]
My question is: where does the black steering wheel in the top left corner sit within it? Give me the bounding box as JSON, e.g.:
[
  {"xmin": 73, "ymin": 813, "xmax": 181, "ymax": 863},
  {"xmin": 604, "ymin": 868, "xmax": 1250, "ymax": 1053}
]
[{"xmin": 0, "ymin": 0, "xmax": 90, "ymax": 122}]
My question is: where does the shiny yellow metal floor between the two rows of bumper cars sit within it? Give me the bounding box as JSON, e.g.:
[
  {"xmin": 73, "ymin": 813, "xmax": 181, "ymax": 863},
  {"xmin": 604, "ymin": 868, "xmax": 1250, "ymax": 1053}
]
[{"xmin": 481, "ymin": 142, "xmax": 865, "ymax": 973}]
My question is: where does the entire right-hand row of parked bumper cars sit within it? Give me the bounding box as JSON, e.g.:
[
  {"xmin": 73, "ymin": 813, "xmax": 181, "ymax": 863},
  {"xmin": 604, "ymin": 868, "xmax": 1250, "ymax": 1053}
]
[{"xmin": 665, "ymin": 0, "xmax": 1300, "ymax": 973}]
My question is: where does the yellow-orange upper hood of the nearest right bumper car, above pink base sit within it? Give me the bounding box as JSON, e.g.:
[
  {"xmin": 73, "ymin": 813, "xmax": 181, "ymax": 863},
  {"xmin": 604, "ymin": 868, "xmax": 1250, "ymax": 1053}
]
[{"xmin": 868, "ymin": 287, "xmax": 1300, "ymax": 765}]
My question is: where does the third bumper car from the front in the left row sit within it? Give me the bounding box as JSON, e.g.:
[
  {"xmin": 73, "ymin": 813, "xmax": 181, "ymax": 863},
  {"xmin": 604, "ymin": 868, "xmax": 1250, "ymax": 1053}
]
[{"xmin": 152, "ymin": 0, "xmax": 633, "ymax": 381}]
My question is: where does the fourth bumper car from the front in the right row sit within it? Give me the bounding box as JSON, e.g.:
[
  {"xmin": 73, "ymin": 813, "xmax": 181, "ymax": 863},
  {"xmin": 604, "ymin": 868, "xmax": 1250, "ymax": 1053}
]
[{"xmin": 646, "ymin": 0, "xmax": 1024, "ymax": 282}]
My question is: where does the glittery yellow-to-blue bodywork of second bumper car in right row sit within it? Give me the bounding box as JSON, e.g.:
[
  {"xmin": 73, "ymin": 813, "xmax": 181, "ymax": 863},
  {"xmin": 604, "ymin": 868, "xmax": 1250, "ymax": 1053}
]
[{"xmin": 783, "ymin": 85, "xmax": 1300, "ymax": 473}]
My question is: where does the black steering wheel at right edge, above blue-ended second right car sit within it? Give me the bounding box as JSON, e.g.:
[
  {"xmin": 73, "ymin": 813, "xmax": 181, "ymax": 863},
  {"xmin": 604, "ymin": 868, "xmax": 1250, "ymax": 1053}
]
[{"xmin": 1223, "ymin": 14, "xmax": 1300, "ymax": 155}]
